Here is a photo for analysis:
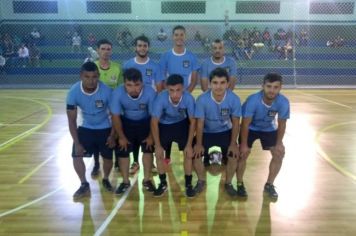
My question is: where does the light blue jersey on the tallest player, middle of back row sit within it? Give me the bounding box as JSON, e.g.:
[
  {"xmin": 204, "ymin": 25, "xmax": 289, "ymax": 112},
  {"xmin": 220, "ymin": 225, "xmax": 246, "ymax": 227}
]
[{"xmin": 159, "ymin": 49, "xmax": 199, "ymax": 89}]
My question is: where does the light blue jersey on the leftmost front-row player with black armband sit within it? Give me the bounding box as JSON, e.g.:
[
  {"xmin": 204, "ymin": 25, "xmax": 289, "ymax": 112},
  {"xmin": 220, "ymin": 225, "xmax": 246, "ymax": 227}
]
[{"xmin": 67, "ymin": 81, "xmax": 111, "ymax": 129}]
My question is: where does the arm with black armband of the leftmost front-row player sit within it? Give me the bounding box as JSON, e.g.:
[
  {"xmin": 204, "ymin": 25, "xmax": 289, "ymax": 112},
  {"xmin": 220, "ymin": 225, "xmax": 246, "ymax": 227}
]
[{"xmin": 67, "ymin": 105, "xmax": 84, "ymax": 157}]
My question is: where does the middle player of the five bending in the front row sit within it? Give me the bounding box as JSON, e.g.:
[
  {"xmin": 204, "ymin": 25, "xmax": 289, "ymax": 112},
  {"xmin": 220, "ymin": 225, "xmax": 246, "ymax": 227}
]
[{"xmin": 151, "ymin": 74, "xmax": 205, "ymax": 197}]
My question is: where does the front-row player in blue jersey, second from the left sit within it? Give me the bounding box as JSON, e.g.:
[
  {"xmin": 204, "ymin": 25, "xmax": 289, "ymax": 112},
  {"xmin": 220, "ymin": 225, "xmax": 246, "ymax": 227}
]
[{"xmin": 110, "ymin": 68, "xmax": 156, "ymax": 194}]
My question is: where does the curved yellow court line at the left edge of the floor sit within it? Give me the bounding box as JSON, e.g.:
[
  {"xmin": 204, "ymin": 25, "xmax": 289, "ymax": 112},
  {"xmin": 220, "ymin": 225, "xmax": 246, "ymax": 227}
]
[{"xmin": 0, "ymin": 96, "xmax": 52, "ymax": 151}]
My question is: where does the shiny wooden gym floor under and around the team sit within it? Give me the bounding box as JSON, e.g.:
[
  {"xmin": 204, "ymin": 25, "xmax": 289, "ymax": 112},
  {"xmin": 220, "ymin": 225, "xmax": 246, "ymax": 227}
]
[{"xmin": 0, "ymin": 90, "xmax": 356, "ymax": 236}]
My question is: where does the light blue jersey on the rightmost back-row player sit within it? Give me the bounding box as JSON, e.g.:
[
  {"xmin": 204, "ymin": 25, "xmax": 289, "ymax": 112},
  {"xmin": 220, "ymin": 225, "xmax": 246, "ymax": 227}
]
[{"xmin": 201, "ymin": 57, "xmax": 237, "ymax": 79}]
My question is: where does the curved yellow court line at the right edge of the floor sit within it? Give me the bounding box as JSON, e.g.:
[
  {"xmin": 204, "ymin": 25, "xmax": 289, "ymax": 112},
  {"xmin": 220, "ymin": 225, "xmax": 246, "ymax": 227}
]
[{"xmin": 315, "ymin": 121, "xmax": 356, "ymax": 182}]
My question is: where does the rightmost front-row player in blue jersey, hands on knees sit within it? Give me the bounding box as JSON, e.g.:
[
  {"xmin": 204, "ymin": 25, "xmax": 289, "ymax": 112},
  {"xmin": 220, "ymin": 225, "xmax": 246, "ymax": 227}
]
[{"xmin": 236, "ymin": 73, "xmax": 290, "ymax": 199}]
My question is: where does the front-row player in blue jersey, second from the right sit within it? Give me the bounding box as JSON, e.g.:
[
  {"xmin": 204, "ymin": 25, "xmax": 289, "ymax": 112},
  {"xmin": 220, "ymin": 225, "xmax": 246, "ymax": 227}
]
[{"xmin": 194, "ymin": 68, "xmax": 241, "ymax": 196}]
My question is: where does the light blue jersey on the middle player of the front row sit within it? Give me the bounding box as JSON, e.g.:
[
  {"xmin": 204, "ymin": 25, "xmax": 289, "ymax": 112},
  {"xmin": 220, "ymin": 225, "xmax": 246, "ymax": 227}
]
[{"xmin": 152, "ymin": 90, "xmax": 195, "ymax": 124}]
